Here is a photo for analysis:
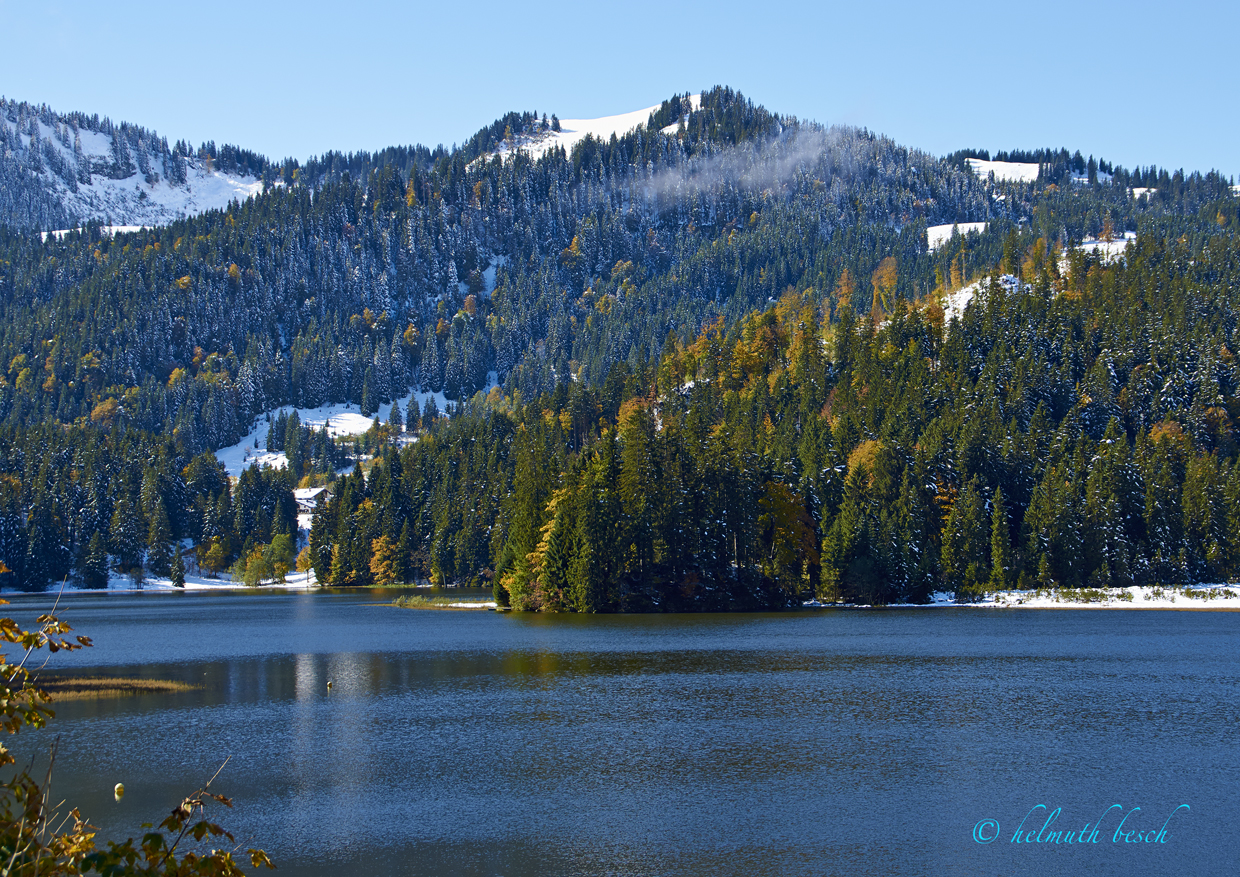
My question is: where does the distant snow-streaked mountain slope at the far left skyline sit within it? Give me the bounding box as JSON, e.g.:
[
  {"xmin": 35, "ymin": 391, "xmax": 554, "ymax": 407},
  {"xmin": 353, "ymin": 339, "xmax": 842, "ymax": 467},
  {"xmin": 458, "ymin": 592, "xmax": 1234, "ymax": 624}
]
[{"xmin": 0, "ymin": 99, "xmax": 267, "ymax": 231}]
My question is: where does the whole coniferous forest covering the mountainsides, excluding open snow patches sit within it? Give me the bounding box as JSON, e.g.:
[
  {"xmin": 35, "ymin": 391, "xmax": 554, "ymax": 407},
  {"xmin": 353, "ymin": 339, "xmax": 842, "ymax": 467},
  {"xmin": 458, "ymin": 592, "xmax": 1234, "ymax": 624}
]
[{"xmin": 0, "ymin": 88, "xmax": 1240, "ymax": 602}]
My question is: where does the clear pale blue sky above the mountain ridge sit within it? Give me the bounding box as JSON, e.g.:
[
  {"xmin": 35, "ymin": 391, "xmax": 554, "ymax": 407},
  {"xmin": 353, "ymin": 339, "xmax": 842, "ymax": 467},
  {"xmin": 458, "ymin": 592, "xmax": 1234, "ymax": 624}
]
[{"xmin": 0, "ymin": 0, "xmax": 1240, "ymax": 176}]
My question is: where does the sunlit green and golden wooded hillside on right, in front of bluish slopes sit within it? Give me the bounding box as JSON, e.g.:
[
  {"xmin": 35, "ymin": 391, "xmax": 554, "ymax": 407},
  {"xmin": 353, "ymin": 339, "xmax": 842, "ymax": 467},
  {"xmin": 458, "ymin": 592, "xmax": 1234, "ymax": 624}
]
[{"xmin": 311, "ymin": 223, "xmax": 1240, "ymax": 612}]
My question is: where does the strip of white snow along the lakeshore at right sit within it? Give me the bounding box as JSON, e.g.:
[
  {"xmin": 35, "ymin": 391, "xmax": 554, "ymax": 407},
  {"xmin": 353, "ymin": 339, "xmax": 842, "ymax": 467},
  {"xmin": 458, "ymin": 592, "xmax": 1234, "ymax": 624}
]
[{"xmin": 802, "ymin": 584, "xmax": 1240, "ymax": 612}]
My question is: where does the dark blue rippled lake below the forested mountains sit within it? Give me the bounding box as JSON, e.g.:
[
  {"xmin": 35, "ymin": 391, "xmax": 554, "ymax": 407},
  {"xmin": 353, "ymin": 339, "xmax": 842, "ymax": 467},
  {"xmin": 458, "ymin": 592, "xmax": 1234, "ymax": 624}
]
[{"xmin": 6, "ymin": 593, "xmax": 1240, "ymax": 877}]
